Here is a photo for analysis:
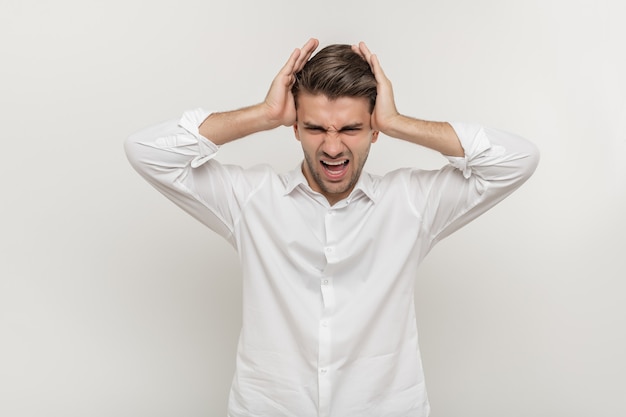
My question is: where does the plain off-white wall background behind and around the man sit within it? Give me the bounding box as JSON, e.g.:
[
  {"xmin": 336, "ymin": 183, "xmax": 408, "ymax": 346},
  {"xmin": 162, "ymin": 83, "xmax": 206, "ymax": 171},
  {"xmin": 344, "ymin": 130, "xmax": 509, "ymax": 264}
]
[{"xmin": 0, "ymin": 0, "xmax": 626, "ymax": 417}]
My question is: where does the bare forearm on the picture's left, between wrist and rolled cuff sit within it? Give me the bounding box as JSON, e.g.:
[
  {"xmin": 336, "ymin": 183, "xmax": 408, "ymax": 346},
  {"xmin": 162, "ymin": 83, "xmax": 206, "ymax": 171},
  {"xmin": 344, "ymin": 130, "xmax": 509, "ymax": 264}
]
[{"xmin": 198, "ymin": 104, "xmax": 280, "ymax": 145}]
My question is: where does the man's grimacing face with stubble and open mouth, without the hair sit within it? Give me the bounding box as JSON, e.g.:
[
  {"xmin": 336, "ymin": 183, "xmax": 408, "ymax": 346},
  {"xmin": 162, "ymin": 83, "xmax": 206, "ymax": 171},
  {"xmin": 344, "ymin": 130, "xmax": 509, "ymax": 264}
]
[{"xmin": 293, "ymin": 92, "xmax": 378, "ymax": 205}]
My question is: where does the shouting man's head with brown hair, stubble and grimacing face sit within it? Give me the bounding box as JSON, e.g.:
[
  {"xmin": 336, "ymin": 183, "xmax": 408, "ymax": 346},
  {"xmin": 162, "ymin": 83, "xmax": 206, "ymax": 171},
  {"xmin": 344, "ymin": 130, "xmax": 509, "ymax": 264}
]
[{"xmin": 292, "ymin": 45, "xmax": 378, "ymax": 205}]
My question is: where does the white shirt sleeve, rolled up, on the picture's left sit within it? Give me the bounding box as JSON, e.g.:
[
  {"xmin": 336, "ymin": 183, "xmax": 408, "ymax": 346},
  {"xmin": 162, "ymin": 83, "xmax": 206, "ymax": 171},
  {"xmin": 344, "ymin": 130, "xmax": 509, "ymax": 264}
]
[{"xmin": 125, "ymin": 109, "xmax": 262, "ymax": 245}]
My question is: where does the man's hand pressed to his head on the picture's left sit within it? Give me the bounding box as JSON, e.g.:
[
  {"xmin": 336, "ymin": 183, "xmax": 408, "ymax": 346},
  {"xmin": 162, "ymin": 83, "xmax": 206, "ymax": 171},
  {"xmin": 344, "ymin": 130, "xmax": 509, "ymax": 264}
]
[{"xmin": 263, "ymin": 38, "xmax": 319, "ymax": 126}]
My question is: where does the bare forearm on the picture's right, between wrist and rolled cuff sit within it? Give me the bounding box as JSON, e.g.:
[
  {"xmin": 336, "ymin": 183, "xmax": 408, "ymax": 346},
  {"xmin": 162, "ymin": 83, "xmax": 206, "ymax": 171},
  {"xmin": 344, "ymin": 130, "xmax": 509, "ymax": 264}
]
[{"xmin": 381, "ymin": 114, "xmax": 465, "ymax": 157}]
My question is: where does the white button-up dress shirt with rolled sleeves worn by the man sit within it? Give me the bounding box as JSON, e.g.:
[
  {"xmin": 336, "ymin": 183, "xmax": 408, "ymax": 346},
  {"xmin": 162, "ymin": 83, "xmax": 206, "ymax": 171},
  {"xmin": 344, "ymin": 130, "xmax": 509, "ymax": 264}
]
[{"xmin": 126, "ymin": 110, "xmax": 538, "ymax": 417}]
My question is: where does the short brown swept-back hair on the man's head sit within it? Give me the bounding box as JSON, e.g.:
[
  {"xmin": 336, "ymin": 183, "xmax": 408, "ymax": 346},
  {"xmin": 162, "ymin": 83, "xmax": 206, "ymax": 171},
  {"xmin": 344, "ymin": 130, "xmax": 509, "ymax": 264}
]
[{"xmin": 291, "ymin": 45, "xmax": 376, "ymax": 113}]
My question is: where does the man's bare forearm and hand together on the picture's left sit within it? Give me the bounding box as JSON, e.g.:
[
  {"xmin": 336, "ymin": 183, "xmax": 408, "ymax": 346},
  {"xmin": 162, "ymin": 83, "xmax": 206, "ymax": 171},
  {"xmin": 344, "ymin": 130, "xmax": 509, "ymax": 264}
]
[{"xmin": 198, "ymin": 38, "xmax": 319, "ymax": 145}]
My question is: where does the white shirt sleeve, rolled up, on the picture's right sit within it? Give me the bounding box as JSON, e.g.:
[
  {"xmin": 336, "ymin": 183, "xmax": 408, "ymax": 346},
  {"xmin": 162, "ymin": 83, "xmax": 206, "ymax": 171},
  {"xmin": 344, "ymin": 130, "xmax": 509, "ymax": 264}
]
[{"xmin": 411, "ymin": 123, "xmax": 539, "ymax": 245}]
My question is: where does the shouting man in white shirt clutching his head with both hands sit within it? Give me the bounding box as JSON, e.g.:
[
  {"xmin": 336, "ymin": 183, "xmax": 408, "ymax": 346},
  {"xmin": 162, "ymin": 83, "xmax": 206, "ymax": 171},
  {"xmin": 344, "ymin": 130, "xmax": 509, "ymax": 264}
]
[{"xmin": 126, "ymin": 39, "xmax": 538, "ymax": 417}]
